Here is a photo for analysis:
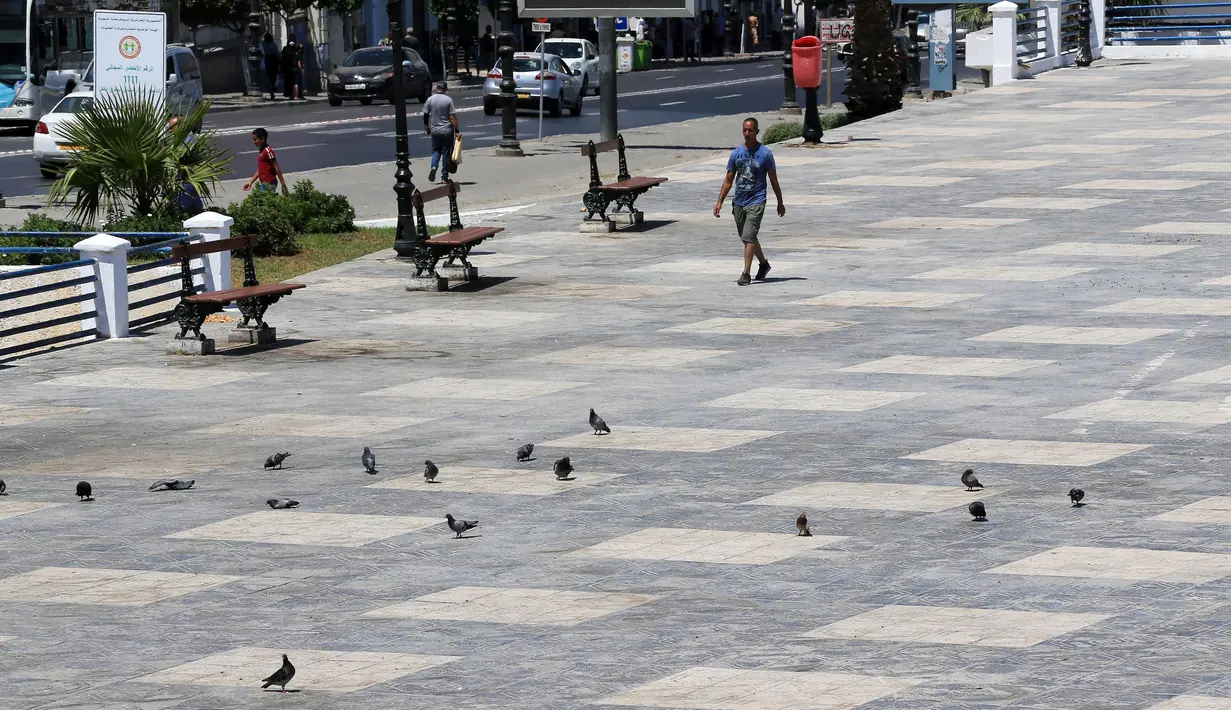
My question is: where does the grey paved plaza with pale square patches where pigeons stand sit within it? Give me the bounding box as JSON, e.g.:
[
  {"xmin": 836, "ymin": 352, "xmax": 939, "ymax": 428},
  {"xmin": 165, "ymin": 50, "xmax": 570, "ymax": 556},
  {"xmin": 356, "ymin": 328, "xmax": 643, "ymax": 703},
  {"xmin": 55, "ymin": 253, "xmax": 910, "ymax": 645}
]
[{"xmin": 0, "ymin": 63, "xmax": 1231, "ymax": 710}]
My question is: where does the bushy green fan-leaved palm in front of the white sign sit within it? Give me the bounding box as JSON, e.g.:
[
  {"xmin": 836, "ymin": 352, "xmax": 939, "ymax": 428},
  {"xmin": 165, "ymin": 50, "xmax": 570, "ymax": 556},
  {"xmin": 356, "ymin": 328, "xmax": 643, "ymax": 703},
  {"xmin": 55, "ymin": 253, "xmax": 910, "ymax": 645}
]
[{"xmin": 48, "ymin": 92, "xmax": 230, "ymax": 224}]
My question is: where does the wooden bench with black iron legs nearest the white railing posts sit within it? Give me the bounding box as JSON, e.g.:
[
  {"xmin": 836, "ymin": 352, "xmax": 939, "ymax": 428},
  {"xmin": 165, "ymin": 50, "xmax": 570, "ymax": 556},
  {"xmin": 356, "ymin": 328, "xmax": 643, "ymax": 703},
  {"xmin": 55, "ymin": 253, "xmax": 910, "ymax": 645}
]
[{"xmin": 171, "ymin": 236, "xmax": 304, "ymax": 341}]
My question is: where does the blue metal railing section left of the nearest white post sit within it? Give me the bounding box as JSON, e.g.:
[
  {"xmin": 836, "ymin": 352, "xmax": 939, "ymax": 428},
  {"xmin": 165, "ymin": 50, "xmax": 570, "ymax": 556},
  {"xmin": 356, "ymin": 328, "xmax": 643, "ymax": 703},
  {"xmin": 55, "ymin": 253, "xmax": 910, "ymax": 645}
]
[{"xmin": 0, "ymin": 258, "xmax": 98, "ymax": 357}]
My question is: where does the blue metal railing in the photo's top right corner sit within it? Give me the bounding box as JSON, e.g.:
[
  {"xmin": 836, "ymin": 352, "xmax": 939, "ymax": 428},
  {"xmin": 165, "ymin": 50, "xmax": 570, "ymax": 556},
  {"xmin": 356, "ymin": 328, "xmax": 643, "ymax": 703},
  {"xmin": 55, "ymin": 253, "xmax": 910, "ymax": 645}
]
[{"xmin": 1107, "ymin": 1, "xmax": 1231, "ymax": 44}]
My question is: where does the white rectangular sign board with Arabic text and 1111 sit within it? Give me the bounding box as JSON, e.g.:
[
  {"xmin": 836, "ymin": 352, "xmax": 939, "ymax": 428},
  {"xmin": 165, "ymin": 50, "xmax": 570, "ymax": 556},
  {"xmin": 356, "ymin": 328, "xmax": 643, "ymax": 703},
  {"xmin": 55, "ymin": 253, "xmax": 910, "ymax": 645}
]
[{"xmin": 94, "ymin": 10, "xmax": 167, "ymax": 102}]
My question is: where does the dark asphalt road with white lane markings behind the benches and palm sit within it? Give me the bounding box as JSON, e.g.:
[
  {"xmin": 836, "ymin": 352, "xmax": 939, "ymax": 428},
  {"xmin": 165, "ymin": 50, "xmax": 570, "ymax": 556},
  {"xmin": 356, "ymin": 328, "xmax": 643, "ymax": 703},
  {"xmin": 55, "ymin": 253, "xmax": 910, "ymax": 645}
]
[{"xmin": 0, "ymin": 62, "xmax": 844, "ymax": 196}]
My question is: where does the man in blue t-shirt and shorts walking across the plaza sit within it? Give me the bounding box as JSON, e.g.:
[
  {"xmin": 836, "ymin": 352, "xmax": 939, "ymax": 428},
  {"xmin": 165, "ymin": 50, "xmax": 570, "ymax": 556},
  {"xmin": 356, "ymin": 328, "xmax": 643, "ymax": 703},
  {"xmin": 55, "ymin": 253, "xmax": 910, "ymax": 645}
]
[{"xmin": 714, "ymin": 118, "xmax": 787, "ymax": 285}]
